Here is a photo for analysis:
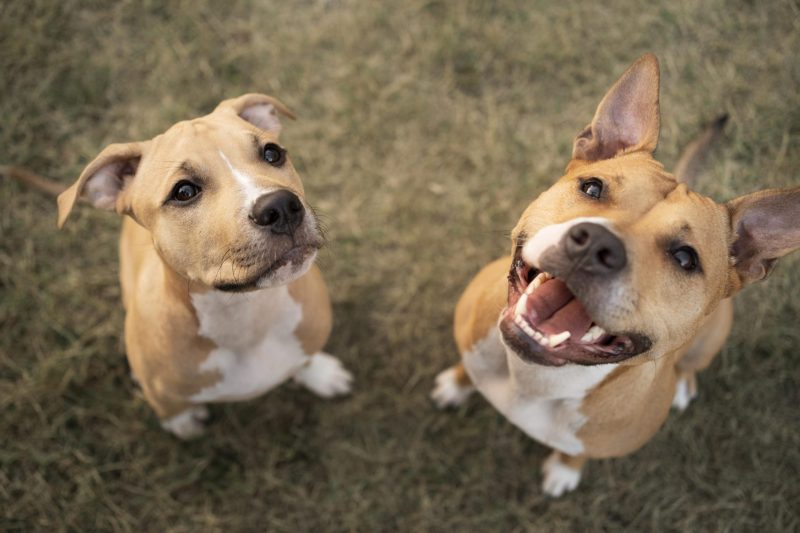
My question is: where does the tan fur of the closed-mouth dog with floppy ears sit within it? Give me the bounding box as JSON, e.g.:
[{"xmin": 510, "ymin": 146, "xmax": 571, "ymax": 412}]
[{"xmin": 50, "ymin": 94, "xmax": 332, "ymax": 432}]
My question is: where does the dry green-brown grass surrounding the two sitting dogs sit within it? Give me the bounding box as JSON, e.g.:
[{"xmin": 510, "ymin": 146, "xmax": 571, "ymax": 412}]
[{"xmin": 0, "ymin": 0, "xmax": 800, "ymax": 532}]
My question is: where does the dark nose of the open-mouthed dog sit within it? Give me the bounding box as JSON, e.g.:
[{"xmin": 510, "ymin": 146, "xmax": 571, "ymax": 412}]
[{"xmin": 564, "ymin": 222, "xmax": 628, "ymax": 274}]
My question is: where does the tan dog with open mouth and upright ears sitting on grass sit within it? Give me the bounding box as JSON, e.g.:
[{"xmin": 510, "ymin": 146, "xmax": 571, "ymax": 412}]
[{"xmin": 432, "ymin": 55, "xmax": 800, "ymax": 496}]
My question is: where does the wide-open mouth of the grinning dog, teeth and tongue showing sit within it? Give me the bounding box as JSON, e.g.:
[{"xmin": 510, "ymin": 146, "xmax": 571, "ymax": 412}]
[{"xmin": 500, "ymin": 247, "xmax": 650, "ymax": 366}]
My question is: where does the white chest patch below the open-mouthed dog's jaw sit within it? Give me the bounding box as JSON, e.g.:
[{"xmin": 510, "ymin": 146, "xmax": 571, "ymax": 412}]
[{"xmin": 464, "ymin": 328, "xmax": 616, "ymax": 455}]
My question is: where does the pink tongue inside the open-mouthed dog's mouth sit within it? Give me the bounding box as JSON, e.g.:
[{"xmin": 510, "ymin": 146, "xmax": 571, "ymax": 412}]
[{"xmin": 528, "ymin": 279, "xmax": 592, "ymax": 341}]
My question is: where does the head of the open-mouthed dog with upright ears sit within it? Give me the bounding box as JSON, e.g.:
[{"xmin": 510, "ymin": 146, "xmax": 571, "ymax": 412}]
[{"xmin": 500, "ymin": 55, "xmax": 800, "ymax": 365}]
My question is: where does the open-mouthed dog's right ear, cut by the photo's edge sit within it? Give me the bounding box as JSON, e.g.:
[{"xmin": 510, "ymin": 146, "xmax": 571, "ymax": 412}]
[{"xmin": 727, "ymin": 187, "xmax": 800, "ymax": 284}]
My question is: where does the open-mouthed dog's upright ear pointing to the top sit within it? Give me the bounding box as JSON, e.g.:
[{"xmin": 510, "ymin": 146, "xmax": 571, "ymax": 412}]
[{"xmin": 572, "ymin": 54, "xmax": 659, "ymax": 161}]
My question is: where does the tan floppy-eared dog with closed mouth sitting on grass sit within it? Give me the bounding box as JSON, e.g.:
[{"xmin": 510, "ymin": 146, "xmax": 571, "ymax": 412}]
[{"xmin": 58, "ymin": 94, "xmax": 352, "ymax": 438}]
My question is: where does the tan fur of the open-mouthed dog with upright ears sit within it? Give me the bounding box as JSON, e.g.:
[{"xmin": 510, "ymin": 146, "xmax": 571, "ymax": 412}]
[{"xmin": 440, "ymin": 55, "xmax": 800, "ymax": 490}]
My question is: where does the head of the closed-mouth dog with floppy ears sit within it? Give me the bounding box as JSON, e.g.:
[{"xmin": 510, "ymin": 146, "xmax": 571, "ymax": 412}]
[{"xmin": 58, "ymin": 94, "xmax": 323, "ymax": 291}]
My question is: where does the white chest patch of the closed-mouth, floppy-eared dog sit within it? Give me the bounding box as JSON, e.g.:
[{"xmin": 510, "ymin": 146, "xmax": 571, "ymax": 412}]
[{"xmin": 192, "ymin": 286, "xmax": 308, "ymax": 402}]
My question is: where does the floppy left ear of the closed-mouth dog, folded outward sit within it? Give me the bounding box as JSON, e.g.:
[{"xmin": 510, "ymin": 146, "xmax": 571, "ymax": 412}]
[{"xmin": 58, "ymin": 142, "xmax": 148, "ymax": 228}]
